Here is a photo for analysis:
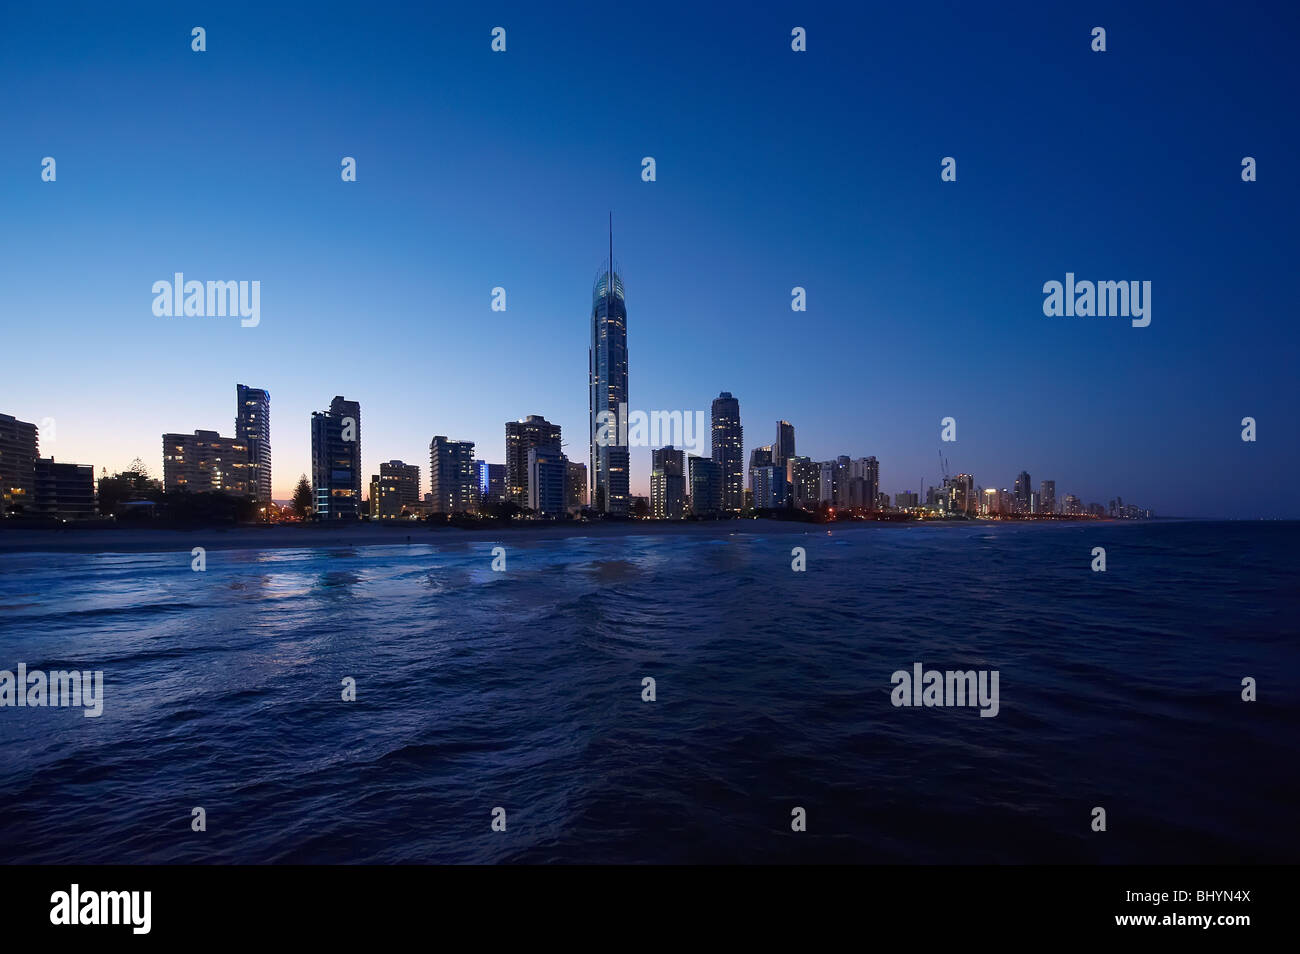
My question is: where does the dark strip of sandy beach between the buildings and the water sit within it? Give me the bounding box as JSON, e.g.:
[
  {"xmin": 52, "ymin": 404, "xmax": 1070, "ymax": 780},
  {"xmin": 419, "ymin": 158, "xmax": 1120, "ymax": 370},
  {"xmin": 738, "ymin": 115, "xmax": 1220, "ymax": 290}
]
[{"xmin": 0, "ymin": 517, "xmax": 1140, "ymax": 555}]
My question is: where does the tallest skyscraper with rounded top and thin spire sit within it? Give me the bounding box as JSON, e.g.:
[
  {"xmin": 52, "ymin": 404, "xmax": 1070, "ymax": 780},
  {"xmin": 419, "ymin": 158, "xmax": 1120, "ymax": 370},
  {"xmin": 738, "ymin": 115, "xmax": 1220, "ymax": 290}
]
[{"xmin": 588, "ymin": 213, "xmax": 631, "ymax": 515}]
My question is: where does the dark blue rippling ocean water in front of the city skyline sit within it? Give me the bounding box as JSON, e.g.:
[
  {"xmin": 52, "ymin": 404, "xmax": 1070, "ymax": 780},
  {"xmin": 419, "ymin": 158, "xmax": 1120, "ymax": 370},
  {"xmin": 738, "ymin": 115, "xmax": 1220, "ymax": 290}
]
[{"xmin": 0, "ymin": 522, "xmax": 1300, "ymax": 863}]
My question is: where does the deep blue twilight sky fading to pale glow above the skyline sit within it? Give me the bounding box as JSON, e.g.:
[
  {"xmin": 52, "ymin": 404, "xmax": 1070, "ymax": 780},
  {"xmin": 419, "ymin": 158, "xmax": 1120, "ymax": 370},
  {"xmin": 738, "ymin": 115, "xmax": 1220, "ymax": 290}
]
[{"xmin": 0, "ymin": 3, "xmax": 1300, "ymax": 519}]
